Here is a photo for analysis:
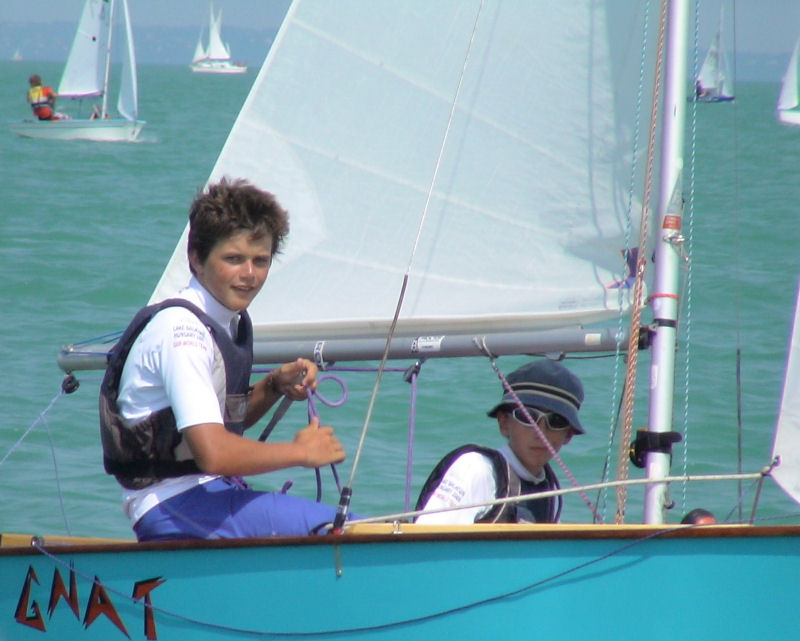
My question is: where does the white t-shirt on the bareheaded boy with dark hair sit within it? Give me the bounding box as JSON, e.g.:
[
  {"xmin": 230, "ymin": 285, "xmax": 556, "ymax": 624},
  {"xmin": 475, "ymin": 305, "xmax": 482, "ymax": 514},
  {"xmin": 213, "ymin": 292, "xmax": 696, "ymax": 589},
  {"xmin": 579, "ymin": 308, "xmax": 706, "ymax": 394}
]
[{"xmin": 118, "ymin": 277, "xmax": 238, "ymax": 524}]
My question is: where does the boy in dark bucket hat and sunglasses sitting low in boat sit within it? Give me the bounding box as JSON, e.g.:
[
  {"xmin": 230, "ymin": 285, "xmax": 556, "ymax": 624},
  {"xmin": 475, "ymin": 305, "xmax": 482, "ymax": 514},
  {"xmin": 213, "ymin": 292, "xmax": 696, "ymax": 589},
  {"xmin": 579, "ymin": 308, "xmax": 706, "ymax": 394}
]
[{"xmin": 416, "ymin": 359, "xmax": 585, "ymax": 524}]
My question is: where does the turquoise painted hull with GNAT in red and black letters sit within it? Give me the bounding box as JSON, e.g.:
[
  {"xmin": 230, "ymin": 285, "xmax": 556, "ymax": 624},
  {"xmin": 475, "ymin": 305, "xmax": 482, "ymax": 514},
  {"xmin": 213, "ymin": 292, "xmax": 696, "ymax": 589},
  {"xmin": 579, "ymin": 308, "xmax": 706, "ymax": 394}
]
[{"xmin": 0, "ymin": 528, "xmax": 800, "ymax": 641}]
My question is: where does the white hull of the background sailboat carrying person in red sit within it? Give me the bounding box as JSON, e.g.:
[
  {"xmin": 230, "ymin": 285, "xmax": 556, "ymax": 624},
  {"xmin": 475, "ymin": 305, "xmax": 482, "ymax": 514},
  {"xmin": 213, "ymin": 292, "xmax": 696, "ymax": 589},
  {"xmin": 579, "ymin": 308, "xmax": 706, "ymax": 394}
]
[{"xmin": 9, "ymin": 119, "xmax": 145, "ymax": 142}]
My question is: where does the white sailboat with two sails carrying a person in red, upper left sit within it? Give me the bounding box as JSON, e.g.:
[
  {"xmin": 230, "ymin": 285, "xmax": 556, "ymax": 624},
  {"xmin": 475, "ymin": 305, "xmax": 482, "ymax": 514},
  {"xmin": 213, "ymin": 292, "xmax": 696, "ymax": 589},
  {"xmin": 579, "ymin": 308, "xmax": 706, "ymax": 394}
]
[{"xmin": 10, "ymin": 0, "xmax": 145, "ymax": 142}]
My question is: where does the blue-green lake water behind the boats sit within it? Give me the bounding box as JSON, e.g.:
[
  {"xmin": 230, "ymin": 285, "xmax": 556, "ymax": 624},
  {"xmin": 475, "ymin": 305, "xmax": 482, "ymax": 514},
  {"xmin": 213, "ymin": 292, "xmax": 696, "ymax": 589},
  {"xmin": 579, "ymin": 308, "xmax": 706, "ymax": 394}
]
[{"xmin": 0, "ymin": 63, "xmax": 800, "ymax": 537}]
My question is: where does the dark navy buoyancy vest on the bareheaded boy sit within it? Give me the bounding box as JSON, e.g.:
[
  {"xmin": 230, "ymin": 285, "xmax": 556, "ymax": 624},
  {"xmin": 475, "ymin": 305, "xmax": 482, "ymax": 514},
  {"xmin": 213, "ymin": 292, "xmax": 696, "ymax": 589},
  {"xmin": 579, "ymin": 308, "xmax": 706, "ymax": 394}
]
[{"xmin": 100, "ymin": 298, "xmax": 253, "ymax": 490}]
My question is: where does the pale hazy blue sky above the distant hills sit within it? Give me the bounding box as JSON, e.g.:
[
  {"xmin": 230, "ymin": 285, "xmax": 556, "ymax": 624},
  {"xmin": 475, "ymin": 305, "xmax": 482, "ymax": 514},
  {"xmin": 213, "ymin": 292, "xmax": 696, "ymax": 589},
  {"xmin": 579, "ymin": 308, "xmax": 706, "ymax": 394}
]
[{"xmin": 0, "ymin": 0, "xmax": 800, "ymax": 55}]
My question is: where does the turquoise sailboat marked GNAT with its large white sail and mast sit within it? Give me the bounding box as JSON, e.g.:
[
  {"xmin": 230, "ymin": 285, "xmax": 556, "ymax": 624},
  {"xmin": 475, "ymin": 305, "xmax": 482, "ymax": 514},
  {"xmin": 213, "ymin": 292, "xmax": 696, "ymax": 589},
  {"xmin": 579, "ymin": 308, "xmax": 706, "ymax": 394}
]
[{"xmin": 0, "ymin": 0, "xmax": 800, "ymax": 641}]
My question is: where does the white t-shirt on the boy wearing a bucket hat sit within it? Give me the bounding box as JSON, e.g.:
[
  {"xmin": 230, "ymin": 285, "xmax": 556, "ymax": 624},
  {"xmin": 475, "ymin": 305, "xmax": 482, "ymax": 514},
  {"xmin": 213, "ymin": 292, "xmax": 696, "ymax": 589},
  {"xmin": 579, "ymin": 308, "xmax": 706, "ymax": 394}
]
[{"xmin": 416, "ymin": 444, "xmax": 544, "ymax": 525}]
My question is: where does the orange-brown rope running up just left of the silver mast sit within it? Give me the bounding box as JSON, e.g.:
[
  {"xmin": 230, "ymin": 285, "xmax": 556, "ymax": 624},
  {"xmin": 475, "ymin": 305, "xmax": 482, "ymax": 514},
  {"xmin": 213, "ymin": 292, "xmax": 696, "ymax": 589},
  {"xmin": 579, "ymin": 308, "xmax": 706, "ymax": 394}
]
[{"xmin": 615, "ymin": 0, "xmax": 667, "ymax": 523}]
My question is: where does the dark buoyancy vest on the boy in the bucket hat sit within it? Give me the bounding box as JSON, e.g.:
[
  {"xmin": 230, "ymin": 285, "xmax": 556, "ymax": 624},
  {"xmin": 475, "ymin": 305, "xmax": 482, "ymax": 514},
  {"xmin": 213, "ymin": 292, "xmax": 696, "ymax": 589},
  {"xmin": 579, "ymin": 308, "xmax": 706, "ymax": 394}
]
[{"xmin": 414, "ymin": 443, "xmax": 562, "ymax": 523}]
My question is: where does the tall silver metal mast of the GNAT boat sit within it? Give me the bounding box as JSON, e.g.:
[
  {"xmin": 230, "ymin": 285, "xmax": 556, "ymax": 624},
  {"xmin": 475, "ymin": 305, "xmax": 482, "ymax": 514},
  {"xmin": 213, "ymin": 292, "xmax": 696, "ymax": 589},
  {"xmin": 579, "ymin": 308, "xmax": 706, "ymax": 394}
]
[{"xmin": 644, "ymin": 0, "xmax": 689, "ymax": 523}]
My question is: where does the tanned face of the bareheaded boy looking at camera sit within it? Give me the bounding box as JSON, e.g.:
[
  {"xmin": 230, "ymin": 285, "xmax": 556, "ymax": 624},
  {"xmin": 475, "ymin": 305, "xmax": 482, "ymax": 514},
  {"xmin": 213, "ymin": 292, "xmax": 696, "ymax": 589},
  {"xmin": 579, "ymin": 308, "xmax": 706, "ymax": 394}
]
[{"xmin": 190, "ymin": 231, "xmax": 272, "ymax": 312}]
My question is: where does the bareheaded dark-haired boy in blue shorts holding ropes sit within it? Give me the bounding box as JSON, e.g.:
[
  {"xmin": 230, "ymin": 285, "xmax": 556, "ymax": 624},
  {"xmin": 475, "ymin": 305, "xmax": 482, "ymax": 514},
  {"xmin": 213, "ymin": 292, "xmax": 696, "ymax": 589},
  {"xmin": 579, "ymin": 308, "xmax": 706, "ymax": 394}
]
[{"xmin": 100, "ymin": 179, "xmax": 345, "ymax": 541}]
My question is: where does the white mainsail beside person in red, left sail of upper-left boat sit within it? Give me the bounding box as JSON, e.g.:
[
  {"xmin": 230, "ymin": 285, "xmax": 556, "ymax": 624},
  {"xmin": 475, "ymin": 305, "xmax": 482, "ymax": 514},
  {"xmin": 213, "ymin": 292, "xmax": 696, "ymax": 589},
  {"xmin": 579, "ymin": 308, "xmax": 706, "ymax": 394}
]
[{"xmin": 58, "ymin": 0, "xmax": 112, "ymax": 98}]
